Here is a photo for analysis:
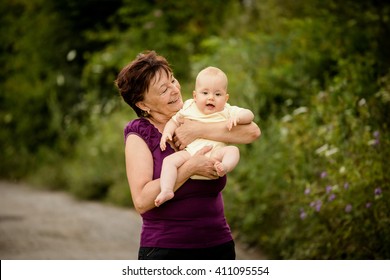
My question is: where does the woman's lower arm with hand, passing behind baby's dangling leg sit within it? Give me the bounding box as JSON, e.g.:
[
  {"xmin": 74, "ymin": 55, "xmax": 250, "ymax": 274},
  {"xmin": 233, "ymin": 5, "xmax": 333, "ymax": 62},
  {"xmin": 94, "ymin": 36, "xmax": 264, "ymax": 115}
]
[{"xmin": 125, "ymin": 135, "xmax": 218, "ymax": 214}]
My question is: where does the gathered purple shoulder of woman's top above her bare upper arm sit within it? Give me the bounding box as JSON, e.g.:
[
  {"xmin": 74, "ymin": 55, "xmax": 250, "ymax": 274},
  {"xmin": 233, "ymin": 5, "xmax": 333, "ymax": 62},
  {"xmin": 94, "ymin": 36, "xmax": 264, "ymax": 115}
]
[{"xmin": 124, "ymin": 118, "xmax": 161, "ymax": 149}]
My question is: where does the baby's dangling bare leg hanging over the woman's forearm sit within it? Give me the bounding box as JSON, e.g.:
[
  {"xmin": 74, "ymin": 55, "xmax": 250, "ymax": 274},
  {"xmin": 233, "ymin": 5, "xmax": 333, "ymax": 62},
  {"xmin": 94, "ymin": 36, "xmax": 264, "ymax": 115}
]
[{"xmin": 154, "ymin": 151, "xmax": 190, "ymax": 207}]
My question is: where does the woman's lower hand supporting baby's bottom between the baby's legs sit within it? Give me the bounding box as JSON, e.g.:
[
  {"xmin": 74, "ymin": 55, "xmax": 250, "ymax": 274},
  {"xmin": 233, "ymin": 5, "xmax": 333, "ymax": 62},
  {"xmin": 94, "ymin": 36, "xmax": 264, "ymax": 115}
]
[{"xmin": 188, "ymin": 146, "xmax": 219, "ymax": 179}]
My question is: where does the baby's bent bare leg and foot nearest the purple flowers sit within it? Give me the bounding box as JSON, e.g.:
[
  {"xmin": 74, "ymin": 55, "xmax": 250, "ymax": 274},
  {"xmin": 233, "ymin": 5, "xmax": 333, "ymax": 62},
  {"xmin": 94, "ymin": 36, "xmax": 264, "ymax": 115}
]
[{"xmin": 211, "ymin": 146, "xmax": 240, "ymax": 177}]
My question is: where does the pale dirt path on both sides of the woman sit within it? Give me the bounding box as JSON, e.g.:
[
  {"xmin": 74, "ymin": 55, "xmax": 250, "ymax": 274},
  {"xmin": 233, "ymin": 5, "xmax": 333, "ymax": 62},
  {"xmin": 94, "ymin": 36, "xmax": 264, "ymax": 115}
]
[{"xmin": 0, "ymin": 181, "xmax": 264, "ymax": 260}]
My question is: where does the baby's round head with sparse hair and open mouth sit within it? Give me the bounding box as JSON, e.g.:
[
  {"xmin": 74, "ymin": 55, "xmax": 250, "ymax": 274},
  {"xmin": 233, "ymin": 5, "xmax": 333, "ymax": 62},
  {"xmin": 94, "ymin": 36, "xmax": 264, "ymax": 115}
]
[{"xmin": 193, "ymin": 66, "xmax": 229, "ymax": 115}]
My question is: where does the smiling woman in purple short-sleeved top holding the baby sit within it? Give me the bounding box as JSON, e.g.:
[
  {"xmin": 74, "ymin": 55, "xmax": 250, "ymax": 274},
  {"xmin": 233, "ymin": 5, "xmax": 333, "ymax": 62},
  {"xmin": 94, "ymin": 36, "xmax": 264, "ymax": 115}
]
[{"xmin": 116, "ymin": 51, "xmax": 260, "ymax": 260}]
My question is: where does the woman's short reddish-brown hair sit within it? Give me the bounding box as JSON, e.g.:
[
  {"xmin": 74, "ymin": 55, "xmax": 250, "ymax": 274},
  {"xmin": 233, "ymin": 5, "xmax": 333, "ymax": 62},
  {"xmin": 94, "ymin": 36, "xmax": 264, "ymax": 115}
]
[{"xmin": 115, "ymin": 51, "xmax": 172, "ymax": 117}]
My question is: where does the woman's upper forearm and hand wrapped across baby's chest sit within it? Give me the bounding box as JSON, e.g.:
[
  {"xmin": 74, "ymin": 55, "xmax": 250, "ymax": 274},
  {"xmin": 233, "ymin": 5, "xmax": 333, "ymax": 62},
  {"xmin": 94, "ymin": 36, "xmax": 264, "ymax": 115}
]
[{"xmin": 174, "ymin": 119, "xmax": 261, "ymax": 149}]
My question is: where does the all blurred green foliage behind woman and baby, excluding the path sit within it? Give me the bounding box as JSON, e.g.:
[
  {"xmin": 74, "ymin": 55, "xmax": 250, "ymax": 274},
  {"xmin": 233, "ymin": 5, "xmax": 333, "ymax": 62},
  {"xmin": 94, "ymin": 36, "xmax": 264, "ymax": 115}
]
[{"xmin": 0, "ymin": 0, "xmax": 390, "ymax": 259}]
